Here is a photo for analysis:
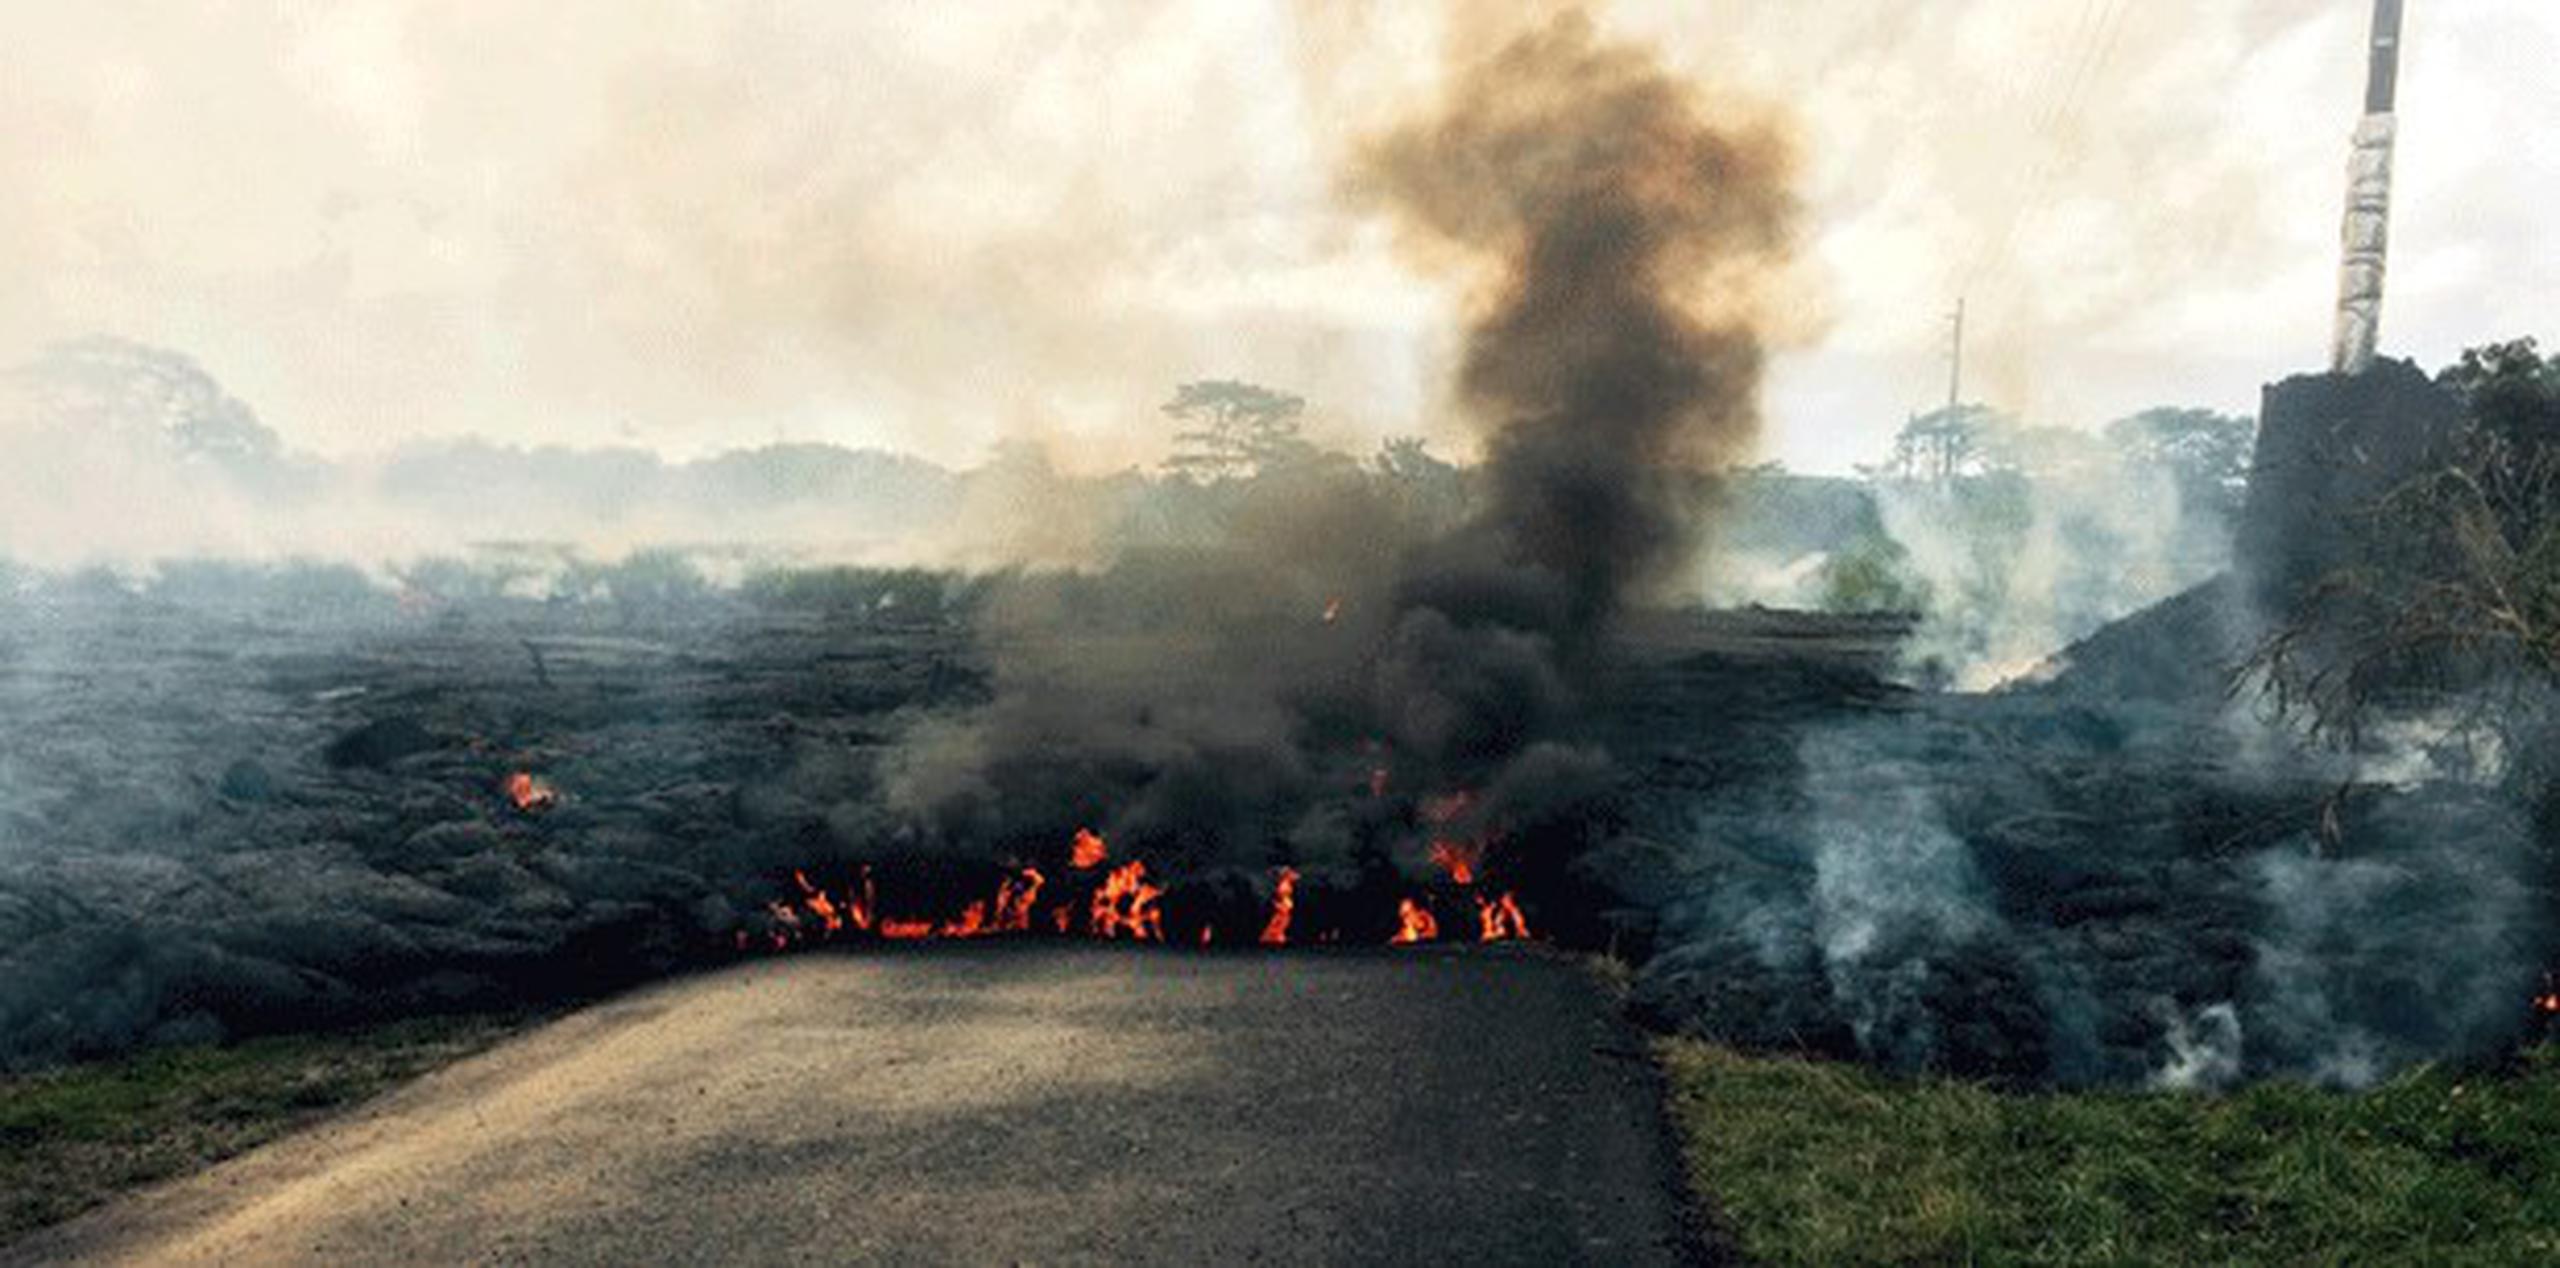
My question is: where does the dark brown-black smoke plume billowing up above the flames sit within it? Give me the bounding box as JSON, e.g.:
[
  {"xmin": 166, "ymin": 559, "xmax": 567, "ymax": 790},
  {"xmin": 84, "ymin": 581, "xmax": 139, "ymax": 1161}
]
[{"xmin": 870, "ymin": 15, "xmax": 1795, "ymax": 904}]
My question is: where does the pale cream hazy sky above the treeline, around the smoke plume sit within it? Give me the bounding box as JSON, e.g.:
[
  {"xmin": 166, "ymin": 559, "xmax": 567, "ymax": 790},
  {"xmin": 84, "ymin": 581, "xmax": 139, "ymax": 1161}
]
[{"xmin": 0, "ymin": 0, "xmax": 2560, "ymax": 471}]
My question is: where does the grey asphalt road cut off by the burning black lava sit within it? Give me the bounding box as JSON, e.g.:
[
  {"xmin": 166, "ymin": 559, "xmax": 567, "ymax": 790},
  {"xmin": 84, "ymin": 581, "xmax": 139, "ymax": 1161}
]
[{"xmin": 20, "ymin": 945, "xmax": 1690, "ymax": 1265}]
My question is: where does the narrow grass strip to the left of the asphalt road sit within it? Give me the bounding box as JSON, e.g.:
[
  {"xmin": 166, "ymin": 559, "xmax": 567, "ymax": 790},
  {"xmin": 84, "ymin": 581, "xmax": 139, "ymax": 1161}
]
[{"xmin": 0, "ymin": 1014, "xmax": 532, "ymax": 1242}]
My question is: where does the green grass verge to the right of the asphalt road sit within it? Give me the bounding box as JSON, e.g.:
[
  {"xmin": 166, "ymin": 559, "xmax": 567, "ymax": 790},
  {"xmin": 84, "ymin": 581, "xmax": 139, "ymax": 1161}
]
[{"xmin": 1661, "ymin": 1040, "xmax": 2560, "ymax": 1265}]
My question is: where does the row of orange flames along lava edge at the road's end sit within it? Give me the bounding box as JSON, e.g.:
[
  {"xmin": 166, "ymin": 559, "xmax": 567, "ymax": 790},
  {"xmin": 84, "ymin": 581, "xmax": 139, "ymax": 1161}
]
[{"xmin": 735, "ymin": 830, "xmax": 1531, "ymax": 950}]
